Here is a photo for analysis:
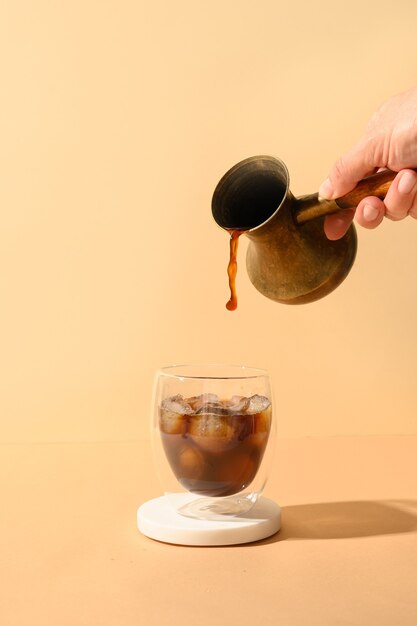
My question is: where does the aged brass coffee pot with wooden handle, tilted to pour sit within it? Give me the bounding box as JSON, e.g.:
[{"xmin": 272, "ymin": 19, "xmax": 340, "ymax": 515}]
[{"xmin": 212, "ymin": 156, "xmax": 396, "ymax": 304}]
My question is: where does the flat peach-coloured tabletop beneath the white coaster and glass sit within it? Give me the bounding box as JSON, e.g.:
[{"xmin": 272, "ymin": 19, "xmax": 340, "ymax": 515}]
[{"xmin": 0, "ymin": 437, "xmax": 417, "ymax": 626}]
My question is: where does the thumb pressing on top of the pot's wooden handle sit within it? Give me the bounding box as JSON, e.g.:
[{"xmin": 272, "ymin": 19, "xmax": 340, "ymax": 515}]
[{"xmin": 319, "ymin": 143, "xmax": 376, "ymax": 200}]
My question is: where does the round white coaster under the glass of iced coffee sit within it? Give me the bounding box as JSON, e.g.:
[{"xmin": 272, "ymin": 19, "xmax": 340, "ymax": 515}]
[{"xmin": 137, "ymin": 496, "xmax": 281, "ymax": 546}]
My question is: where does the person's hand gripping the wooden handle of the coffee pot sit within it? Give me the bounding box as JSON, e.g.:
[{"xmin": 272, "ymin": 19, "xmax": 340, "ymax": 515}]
[{"xmin": 319, "ymin": 87, "xmax": 417, "ymax": 239}]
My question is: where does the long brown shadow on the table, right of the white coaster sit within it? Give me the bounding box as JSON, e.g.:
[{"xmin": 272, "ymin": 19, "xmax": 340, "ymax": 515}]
[{"xmin": 257, "ymin": 500, "xmax": 417, "ymax": 544}]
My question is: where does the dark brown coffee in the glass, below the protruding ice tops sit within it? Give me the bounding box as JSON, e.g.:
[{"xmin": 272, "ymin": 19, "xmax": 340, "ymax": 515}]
[{"xmin": 160, "ymin": 406, "xmax": 271, "ymax": 496}]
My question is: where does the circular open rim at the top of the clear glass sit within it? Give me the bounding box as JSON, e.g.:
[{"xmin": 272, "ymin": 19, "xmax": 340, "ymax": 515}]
[{"xmin": 157, "ymin": 363, "xmax": 269, "ymax": 380}]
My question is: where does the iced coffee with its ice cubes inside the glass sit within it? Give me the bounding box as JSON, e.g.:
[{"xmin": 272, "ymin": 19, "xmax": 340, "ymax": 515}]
[{"xmin": 159, "ymin": 393, "xmax": 271, "ymax": 496}]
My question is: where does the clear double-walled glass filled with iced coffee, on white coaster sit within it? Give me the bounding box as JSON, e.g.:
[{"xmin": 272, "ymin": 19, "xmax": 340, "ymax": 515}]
[{"xmin": 152, "ymin": 365, "xmax": 275, "ymax": 519}]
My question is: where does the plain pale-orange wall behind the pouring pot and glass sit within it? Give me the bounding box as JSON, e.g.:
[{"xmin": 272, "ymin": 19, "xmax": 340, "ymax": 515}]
[{"xmin": 0, "ymin": 0, "xmax": 417, "ymax": 442}]
